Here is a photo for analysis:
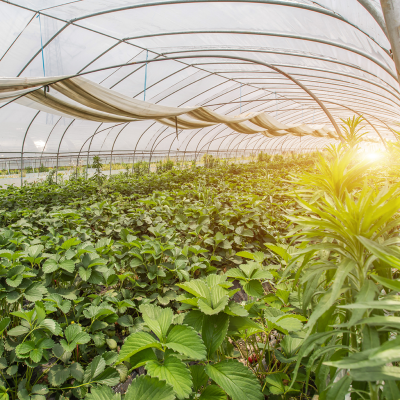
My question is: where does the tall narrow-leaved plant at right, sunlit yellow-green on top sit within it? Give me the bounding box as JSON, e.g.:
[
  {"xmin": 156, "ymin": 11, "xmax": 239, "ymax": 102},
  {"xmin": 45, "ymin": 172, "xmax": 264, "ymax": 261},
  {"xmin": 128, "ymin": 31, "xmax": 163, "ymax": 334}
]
[{"xmin": 284, "ymin": 148, "xmax": 400, "ymax": 400}]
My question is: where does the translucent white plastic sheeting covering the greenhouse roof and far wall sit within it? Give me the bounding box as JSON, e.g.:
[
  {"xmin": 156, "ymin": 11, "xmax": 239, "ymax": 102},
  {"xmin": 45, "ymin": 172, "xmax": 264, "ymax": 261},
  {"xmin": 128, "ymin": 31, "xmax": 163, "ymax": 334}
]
[{"xmin": 0, "ymin": 0, "xmax": 400, "ymax": 157}]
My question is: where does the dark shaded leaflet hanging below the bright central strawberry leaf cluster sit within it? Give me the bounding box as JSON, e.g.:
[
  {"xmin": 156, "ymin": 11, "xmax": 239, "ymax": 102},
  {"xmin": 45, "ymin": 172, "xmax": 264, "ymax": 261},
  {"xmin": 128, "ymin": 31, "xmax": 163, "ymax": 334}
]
[{"xmin": 201, "ymin": 313, "xmax": 229, "ymax": 359}]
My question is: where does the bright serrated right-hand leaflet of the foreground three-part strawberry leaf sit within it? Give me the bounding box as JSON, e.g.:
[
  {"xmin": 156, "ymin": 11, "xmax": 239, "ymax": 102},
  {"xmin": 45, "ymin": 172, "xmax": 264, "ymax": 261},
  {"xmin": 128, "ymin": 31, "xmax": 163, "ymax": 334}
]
[{"xmin": 166, "ymin": 325, "xmax": 206, "ymax": 360}]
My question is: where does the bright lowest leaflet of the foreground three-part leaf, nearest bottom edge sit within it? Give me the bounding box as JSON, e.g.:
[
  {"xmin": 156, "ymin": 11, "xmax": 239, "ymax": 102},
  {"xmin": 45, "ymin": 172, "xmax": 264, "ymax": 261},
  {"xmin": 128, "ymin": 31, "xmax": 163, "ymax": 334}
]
[{"xmin": 146, "ymin": 355, "xmax": 192, "ymax": 399}]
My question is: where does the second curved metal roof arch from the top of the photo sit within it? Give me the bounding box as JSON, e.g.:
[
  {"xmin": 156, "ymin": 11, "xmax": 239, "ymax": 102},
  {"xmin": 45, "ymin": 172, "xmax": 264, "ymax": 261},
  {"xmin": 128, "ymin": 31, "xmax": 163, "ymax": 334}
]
[{"xmin": 123, "ymin": 30, "xmax": 397, "ymax": 79}]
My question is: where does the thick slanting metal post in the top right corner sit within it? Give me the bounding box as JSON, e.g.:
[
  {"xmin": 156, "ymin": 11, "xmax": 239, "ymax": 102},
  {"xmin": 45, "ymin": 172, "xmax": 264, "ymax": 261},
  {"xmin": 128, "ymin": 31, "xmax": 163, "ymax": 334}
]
[{"xmin": 381, "ymin": 0, "xmax": 400, "ymax": 82}]
